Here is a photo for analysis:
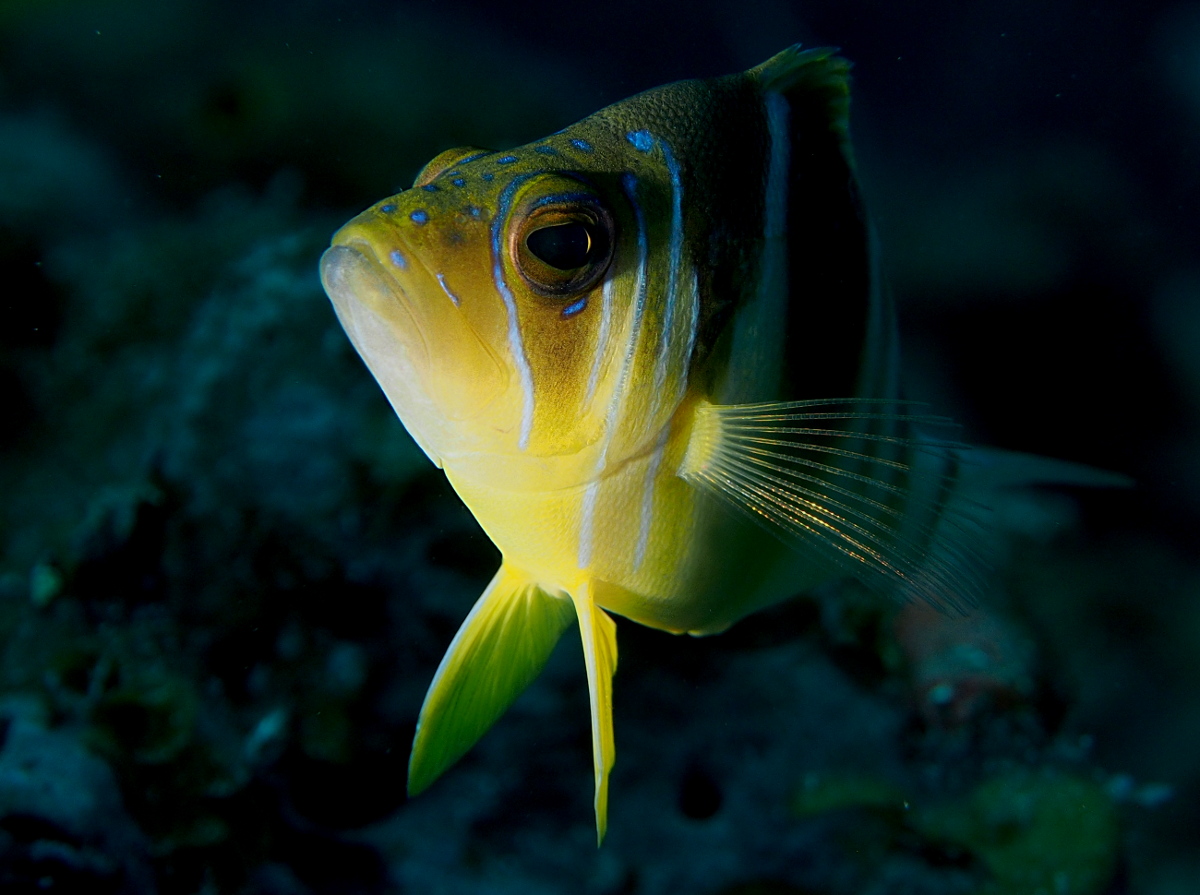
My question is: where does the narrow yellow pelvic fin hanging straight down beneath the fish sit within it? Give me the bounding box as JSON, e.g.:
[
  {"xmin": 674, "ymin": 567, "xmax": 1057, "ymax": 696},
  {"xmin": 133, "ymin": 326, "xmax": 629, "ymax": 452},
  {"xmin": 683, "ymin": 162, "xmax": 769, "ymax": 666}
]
[{"xmin": 571, "ymin": 585, "xmax": 617, "ymax": 846}]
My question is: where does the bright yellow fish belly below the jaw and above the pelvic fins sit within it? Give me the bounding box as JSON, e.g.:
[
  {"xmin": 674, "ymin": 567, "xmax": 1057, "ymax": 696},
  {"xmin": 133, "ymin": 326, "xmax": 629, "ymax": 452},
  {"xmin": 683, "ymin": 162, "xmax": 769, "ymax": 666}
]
[{"xmin": 446, "ymin": 431, "xmax": 832, "ymax": 635}]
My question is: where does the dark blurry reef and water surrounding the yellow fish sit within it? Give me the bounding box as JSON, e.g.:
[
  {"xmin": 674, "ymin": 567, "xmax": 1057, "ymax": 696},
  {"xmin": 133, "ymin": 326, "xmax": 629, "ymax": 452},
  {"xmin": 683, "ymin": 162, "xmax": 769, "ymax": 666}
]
[{"xmin": 0, "ymin": 0, "xmax": 1200, "ymax": 895}]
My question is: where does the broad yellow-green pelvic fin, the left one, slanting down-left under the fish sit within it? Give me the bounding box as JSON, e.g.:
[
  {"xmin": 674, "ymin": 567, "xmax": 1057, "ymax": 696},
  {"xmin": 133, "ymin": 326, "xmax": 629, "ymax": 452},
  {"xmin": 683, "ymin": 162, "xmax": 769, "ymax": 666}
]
[{"xmin": 408, "ymin": 565, "xmax": 571, "ymax": 795}]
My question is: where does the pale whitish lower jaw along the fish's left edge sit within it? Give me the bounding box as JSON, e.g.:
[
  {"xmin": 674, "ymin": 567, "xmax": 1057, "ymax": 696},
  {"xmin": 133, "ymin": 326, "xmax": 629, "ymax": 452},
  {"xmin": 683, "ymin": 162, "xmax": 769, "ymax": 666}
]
[{"xmin": 320, "ymin": 244, "xmax": 442, "ymax": 465}]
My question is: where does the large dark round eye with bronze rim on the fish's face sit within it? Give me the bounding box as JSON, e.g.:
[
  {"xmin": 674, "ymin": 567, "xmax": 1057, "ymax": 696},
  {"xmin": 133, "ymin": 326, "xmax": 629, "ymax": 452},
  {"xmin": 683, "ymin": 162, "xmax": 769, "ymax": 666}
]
[{"xmin": 509, "ymin": 193, "xmax": 616, "ymax": 299}]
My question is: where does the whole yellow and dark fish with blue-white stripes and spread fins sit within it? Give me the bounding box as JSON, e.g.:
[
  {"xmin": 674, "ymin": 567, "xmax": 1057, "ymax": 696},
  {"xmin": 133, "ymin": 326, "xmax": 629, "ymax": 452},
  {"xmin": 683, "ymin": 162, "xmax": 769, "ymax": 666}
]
[{"xmin": 320, "ymin": 47, "xmax": 1118, "ymax": 840}]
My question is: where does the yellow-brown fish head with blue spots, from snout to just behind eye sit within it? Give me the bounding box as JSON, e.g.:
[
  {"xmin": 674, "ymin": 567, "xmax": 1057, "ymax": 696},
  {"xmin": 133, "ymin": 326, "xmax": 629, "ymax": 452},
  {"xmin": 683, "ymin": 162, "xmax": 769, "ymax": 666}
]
[{"xmin": 320, "ymin": 132, "xmax": 696, "ymax": 488}]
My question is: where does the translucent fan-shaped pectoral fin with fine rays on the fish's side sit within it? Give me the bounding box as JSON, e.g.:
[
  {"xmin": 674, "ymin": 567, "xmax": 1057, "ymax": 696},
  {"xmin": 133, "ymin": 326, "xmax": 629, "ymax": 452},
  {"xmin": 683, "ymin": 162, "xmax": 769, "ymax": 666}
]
[{"xmin": 680, "ymin": 398, "xmax": 986, "ymax": 611}]
